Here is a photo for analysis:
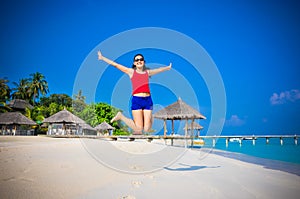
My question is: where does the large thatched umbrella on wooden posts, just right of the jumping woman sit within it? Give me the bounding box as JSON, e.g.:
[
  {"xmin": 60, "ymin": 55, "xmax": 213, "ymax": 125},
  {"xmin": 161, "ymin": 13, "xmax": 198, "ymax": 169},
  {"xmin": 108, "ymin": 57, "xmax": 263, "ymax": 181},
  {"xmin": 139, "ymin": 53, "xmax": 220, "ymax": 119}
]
[{"xmin": 153, "ymin": 98, "xmax": 206, "ymax": 136}]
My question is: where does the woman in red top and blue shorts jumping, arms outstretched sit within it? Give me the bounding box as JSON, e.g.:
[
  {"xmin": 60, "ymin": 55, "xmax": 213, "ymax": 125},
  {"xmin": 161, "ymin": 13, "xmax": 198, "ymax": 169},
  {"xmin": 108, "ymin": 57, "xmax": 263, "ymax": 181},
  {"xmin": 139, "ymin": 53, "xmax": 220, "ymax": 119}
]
[{"xmin": 98, "ymin": 51, "xmax": 172, "ymax": 135}]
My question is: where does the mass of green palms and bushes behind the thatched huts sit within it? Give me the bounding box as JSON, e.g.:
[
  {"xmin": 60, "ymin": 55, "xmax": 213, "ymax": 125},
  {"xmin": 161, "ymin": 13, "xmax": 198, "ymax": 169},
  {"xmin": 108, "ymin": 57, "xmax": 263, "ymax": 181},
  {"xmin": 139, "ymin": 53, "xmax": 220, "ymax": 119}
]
[{"xmin": 0, "ymin": 72, "xmax": 129, "ymax": 135}]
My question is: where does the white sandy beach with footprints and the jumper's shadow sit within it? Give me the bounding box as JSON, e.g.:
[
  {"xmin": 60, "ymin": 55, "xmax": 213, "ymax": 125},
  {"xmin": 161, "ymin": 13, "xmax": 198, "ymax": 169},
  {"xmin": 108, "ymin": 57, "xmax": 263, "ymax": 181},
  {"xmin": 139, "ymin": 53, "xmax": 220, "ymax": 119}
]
[{"xmin": 0, "ymin": 136, "xmax": 300, "ymax": 199}]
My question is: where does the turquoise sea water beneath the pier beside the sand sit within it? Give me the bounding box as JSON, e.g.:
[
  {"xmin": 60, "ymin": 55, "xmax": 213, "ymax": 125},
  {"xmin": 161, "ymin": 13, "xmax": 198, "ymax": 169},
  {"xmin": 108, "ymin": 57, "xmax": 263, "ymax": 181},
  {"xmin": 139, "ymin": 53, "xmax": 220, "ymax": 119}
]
[{"xmin": 195, "ymin": 138, "xmax": 300, "ymax": 176}]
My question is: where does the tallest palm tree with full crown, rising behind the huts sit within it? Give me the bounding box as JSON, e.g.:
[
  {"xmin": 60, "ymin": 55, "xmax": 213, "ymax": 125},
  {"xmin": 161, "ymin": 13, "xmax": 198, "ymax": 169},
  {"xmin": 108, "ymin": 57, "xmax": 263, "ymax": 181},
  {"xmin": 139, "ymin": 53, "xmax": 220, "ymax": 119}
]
[{"xmin": 29, "ymin": 72, "xmax": 49, "ymax": 104}]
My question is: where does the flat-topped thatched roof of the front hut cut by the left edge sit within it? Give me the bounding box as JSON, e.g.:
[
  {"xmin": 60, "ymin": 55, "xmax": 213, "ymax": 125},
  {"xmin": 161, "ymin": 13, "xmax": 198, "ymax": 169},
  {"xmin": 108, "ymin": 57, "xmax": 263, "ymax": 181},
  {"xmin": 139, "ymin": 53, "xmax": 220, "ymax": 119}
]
[{"xmin": 0, "ymin": 112, "xmax": 36, "ymax": 125}]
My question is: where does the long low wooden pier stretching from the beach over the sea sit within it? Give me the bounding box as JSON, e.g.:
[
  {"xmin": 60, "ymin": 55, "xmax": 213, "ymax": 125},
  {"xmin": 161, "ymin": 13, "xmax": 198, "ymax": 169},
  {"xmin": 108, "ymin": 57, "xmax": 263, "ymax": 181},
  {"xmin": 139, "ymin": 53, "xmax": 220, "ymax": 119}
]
[{"xmin": 45, "ymin": 135, "xmax": 298, "ymax": 147}]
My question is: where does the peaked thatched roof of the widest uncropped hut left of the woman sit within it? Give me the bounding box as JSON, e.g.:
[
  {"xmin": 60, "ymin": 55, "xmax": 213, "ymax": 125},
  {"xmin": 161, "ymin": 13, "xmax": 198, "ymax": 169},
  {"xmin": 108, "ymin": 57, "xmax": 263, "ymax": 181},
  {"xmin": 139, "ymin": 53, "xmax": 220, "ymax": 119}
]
[{"xmin": 43, "ymin": 109, "xmax": 85, "ymax": 124}]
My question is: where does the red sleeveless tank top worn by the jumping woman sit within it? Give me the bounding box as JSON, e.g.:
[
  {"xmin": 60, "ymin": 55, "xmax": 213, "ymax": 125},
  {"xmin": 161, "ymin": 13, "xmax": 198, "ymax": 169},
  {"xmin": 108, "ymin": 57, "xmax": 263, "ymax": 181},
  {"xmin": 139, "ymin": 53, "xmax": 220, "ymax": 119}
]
[{"xmin": 131, "ymin": 70, "xmax": 150, "ymax": 95}]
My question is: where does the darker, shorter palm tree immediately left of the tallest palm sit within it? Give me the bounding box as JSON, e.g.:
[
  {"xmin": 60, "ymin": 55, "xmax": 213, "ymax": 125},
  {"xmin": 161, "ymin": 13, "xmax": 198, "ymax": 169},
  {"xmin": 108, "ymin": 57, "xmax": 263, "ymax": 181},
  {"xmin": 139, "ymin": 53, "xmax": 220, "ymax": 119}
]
[{"xmin": 12, "ymin": 79, "xmax": 31, "ymax": 102}]
